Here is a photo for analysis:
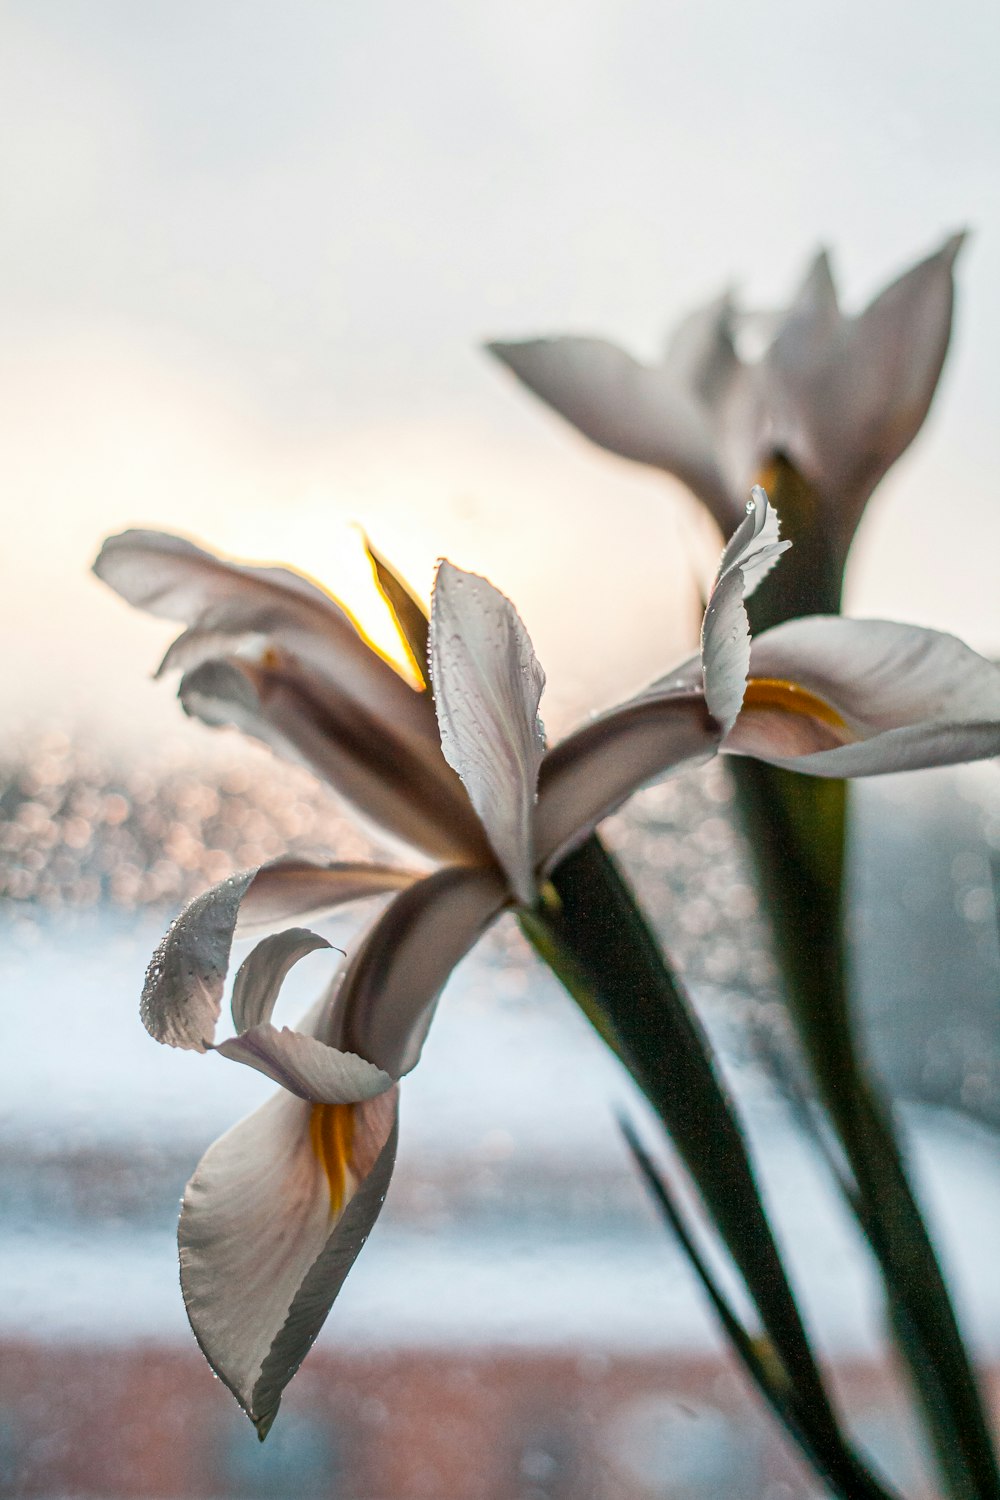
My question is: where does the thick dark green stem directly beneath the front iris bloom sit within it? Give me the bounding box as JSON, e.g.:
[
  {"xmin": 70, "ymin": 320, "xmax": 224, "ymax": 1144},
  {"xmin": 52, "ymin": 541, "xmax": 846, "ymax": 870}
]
[{"xmin": 522, "ymin": 837, "xmax": 886, "ymax": 1500}]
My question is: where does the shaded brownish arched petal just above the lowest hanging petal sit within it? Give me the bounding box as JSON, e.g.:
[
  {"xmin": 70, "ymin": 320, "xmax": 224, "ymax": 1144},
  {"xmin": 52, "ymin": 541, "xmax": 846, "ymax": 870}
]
[{"xmin": 336, "ymin": 867, "xmax": 510, "ymax": 1079}]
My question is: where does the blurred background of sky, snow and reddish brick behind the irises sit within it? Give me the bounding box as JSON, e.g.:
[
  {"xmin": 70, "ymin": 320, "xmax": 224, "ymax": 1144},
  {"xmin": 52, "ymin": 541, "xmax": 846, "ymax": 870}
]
[{"xmin": 0, "ymin": 0, "xmax": 1000, "ymax": 1500}]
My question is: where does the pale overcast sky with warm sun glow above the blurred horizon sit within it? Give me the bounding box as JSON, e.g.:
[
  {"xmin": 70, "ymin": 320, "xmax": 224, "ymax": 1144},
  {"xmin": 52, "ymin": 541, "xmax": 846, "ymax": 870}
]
[{"xmin": 0, "ymin": 0, "xmax": 1000, "ymax": 750}]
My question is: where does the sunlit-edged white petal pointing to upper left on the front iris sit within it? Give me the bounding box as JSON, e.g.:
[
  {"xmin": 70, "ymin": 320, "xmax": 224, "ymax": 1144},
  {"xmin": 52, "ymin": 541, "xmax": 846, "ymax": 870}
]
[{"xmin": 94, "ymin": 531, "xmax": 436, "ymax": 756}]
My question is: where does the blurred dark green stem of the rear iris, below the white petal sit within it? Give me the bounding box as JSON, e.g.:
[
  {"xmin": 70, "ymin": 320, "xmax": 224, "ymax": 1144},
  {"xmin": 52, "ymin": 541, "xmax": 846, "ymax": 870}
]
[{"xmin": 733, "ymin": 761, "xmax": 1000, "ymax": 1500}]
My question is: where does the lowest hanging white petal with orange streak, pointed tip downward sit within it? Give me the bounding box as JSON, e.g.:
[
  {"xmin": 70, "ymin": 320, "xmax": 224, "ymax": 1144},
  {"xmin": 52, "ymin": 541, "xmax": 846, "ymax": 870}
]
[{"xmin": 178, "ymin": 1089, "xmax": 397, "ymax": 1437}]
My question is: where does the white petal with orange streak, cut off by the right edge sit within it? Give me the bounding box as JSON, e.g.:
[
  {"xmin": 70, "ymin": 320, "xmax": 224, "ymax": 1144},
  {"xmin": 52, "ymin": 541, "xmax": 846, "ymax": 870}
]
[{"xmin": 723, "ymin": 617, "xmax": 1000, "ymax": 777}]
